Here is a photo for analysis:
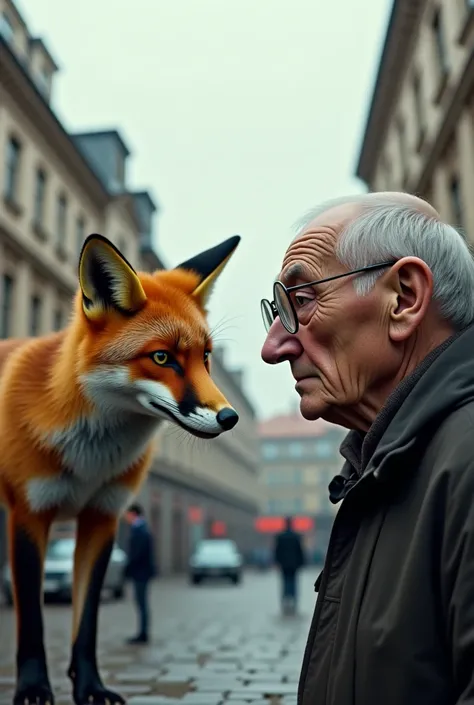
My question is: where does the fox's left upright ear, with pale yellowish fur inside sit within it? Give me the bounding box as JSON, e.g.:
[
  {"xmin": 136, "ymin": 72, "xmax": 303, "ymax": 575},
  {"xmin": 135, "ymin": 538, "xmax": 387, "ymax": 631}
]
[{"xmin": 79, "ymin": 234, "xmax": 147, "ymax": 320}]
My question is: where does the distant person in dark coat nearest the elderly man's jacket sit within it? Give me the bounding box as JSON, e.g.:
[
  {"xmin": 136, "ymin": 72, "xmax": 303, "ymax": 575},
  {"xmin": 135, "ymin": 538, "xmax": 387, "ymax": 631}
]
[{"xmin": 275, "ymin": 517, "xmax": 304, "ymax": 613}]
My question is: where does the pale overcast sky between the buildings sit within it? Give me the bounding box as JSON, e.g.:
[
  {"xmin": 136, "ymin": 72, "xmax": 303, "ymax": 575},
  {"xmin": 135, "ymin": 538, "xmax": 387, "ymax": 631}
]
[{"xmin": 18, "ymin": 0, "xmax": 392, "ymax": 418}]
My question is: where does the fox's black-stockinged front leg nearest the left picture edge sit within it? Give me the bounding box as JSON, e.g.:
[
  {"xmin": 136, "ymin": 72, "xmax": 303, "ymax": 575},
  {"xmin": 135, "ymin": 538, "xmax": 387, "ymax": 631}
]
[{"xmin": 8, "ymin": 507, "xmax": 54, "ymax": 705}]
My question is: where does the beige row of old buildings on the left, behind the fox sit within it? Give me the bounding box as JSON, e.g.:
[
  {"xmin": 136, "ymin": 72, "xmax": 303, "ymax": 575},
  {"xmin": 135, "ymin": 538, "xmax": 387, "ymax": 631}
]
[{"xmin": 0, "ymin": 0, "xmax": 258, "ymax": 573}]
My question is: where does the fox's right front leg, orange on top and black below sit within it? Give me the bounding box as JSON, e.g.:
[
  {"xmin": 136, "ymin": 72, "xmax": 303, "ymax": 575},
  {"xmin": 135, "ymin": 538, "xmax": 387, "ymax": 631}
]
[{"xmin": 68, "ymin": 509, "xmax": 125, "ymax": 705}]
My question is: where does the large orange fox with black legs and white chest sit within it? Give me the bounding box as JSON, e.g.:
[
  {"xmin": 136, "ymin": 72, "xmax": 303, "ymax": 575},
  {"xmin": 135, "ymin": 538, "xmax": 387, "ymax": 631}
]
[{"xmin": 0, "ymin": 233, "xmax": 241, "ymax": 705}]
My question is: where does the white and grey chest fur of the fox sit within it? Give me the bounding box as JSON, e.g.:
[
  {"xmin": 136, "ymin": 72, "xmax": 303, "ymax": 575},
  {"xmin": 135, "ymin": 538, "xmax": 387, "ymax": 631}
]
[{"xmin": 27, "ymin": 413, "xmax": 160, "ymax": 518}]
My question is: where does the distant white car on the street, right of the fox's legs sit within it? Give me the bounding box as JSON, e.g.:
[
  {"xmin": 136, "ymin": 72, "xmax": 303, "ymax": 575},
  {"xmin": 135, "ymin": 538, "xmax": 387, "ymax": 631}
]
[{"xmin": 189, "ymin": 539, "xmax": 243, "ymax": 585}]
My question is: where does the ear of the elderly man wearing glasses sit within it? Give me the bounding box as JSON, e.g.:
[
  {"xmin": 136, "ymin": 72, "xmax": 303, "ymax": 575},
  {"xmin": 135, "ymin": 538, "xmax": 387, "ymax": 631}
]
[{"xmin": 387, "ymin": 257, "xmax": 433, "ymax": 342}]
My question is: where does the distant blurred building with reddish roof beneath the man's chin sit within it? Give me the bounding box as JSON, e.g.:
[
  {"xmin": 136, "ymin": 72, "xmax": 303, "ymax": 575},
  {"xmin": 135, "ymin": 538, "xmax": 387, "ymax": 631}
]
[{"xmin": 259, "ymin": 412, "xmax": 347, "ymax": 553}]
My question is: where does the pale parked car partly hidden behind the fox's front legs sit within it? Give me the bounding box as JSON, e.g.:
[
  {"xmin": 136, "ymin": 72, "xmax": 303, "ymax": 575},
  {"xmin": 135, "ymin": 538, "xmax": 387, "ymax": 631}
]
[{"xmin": 2, "ymin": 537, "xmax": 127, "ymax": 605}]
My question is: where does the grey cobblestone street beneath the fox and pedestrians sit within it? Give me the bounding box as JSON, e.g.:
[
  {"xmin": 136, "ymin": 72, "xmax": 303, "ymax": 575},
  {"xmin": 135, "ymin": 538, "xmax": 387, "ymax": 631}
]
[{"xmin": 0, "ymin": 566, "xmax": 319, "ymax": 705}]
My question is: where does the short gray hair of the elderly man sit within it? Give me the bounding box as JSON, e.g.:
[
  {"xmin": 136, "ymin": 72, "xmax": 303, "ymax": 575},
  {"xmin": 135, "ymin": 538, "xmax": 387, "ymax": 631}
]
[{"xmin": 297, "ymin": 194, "xmax": 474, "ymax": 329}]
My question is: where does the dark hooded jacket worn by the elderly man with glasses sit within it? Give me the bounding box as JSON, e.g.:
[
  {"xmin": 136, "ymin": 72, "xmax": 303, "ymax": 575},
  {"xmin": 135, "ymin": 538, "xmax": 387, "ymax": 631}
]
[{"xmin": 298, "ymin": 326, "xmax": 474, "ymax": 705}]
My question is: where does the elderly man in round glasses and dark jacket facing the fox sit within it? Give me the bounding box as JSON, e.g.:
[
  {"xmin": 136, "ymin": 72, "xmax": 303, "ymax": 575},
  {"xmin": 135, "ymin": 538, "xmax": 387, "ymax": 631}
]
[{"xmin": 262, "ymin": 193, "xmax": 474, "ymax": 705}]
